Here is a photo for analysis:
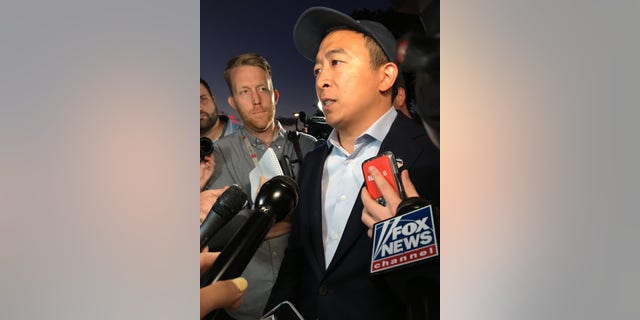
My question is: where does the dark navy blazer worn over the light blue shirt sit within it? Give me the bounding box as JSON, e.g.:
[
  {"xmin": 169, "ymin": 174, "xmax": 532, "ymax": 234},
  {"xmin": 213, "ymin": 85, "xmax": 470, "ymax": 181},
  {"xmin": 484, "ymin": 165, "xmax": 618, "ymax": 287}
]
[{"xmin": 266, "ymin": 113, "xmax": 440, "ymax": 320}]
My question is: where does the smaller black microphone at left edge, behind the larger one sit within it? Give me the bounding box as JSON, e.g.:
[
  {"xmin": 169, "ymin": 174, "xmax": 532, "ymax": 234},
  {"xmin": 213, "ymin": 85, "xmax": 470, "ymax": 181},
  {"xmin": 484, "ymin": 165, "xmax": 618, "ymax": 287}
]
[{"xmin": 200, "ymin": 184, "xmax": 248, "ymax": 250}]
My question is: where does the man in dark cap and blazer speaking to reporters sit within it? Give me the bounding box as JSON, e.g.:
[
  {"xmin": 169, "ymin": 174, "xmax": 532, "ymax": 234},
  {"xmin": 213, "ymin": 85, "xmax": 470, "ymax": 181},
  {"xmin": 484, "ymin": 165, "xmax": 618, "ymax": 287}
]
[{"xmin": 267, "ymin": 7, "xmax": 439, "ymax": 319}]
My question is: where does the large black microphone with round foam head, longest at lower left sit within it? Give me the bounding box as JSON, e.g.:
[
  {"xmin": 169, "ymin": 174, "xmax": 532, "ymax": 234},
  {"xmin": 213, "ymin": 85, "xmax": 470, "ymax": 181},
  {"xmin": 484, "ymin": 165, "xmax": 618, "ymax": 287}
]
[{"xmin": 200, "ymin": 176, "xmax": 299, "ymax": 288}]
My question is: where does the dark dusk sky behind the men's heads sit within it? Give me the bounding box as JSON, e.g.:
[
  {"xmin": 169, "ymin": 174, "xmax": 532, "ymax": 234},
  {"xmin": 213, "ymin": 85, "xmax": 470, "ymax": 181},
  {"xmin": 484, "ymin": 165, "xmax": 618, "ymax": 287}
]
[{"xmin": 200, "ymin": 0, "xmax": 390, "ymax": 117}]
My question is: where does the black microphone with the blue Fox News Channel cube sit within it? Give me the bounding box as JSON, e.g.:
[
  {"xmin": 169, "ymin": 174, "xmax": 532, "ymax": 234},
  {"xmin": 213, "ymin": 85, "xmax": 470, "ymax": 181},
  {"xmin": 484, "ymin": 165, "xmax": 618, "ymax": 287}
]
[{"xmin": 369, "ymin": 197, "xmax": 440, "ymax": 320}]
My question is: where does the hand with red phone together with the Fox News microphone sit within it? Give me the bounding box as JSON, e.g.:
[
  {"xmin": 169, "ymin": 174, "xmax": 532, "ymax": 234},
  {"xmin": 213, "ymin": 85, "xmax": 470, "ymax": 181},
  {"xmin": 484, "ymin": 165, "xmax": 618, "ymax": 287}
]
[{"xmin": 360, "ymin": 158, "xmax": 440, "ymax": 320}]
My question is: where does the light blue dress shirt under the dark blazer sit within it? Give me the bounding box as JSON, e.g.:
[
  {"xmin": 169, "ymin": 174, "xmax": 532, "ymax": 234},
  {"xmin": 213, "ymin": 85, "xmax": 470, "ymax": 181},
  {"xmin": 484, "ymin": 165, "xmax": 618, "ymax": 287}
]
[{"xmin": 322, "ymin": 107, "xmax": 398, "ymax": 268}]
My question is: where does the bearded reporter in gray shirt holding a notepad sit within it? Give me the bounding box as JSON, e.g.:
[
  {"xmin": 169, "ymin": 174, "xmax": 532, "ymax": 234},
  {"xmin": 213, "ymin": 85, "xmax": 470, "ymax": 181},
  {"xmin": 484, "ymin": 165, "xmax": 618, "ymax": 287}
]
[{"xmin": 205, "ymin": 53, "xmax": 316, "ymax": 320}]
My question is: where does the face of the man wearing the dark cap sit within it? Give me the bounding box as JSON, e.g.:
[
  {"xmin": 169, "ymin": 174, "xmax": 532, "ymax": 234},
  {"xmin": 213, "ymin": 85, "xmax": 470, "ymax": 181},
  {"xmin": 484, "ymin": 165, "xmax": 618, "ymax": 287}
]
[{"xmin": 314, "ymin": 30, "xmax": 379, "ymax": 131}]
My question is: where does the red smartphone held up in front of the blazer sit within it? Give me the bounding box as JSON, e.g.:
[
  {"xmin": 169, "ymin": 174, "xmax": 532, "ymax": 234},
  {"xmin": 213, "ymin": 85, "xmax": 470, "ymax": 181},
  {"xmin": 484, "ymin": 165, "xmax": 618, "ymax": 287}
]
[{"xmin": 362, "ymin": 151, "xmax": 406, "ymax": 206}]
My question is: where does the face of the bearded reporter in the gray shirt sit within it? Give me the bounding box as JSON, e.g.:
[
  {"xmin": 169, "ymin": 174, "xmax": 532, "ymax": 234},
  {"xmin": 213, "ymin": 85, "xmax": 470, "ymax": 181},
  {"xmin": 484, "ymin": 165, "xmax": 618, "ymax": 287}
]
[{"xmin": 229, "ymin": 66, "xmax": 278, "ymax": 133}]
